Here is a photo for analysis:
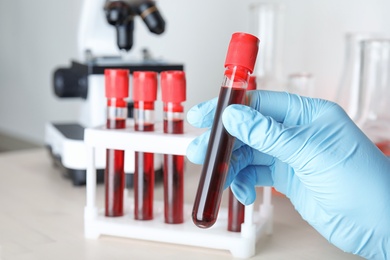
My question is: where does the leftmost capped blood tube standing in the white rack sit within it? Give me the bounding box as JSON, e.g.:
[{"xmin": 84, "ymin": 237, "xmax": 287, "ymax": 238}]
[{"xmin": 104, "ymin": 69, "xmax": 129, "ymax": 217}]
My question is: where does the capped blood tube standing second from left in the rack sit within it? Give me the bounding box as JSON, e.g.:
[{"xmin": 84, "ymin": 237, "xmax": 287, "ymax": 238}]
[{"xmin": 133, "ymin": 71, "xmax": 157, "ymax": 220}]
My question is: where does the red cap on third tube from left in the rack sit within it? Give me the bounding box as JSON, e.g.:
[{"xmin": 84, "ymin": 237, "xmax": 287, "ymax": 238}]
[{"xmin": 161, "ymin": 70, "xmax": 186, "ymax": 103}]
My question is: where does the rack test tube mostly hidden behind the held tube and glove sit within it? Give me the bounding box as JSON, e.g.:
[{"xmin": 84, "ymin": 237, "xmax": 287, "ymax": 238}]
[{"xmin": 227, "ymin": 75, "xmax": 257, "ymax": 232}]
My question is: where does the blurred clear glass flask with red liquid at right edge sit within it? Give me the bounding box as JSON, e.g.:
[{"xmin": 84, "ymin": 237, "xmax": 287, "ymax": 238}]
[{"xmin": 358, "ymin": 39, "xmax": 390, "ymax": 156}]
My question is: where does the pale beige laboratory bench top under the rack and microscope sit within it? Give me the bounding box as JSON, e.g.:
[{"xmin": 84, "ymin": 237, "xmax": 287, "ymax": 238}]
[{"xmin": 0, "ymin": 148, "xmax": 360, "ymax": 260}]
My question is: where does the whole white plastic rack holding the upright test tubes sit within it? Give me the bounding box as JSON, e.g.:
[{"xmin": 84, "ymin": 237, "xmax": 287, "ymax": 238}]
[{"xmin": 84, "ymin": 122, "xmax": 273, "ymax": 258}]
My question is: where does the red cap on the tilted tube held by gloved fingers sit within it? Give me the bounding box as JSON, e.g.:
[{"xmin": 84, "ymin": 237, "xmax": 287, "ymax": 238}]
[{"xmin": 225, "ymin": 32, "xmax": 260, "ymax": 73}]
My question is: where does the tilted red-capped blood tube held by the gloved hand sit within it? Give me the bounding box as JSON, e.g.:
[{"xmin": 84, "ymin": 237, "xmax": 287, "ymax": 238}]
[{"xmin": 192, "ymin": 33, "xmax": 259, "ymax": 228}]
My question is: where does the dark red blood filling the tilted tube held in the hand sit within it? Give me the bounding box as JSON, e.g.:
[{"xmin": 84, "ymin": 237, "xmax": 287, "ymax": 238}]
[{"xmin": 192, "ymin": 87, "xmax": 245, "ymax": 228}]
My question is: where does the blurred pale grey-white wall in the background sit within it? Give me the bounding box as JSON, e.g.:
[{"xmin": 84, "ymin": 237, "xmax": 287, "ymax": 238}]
[{"xmin": 0, "ymin": 0, "xmax": 390, "ymax": 144}]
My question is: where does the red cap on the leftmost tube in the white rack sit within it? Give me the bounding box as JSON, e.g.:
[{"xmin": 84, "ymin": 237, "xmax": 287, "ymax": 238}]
[{"xmin": 104, "ymin": 69, "xmax": 129, "ymax": 98}]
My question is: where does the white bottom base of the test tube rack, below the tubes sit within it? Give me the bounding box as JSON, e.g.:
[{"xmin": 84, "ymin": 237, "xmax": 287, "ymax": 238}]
[{"xmin": 84, "ymin": 201, "xmax": 272, "ymax": 258}]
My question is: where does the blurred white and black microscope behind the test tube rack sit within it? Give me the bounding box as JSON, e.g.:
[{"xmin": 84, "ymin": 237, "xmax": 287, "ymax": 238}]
[{"xmin": 45, "ymin": 0, "xmax": 184, "ymax": 187}]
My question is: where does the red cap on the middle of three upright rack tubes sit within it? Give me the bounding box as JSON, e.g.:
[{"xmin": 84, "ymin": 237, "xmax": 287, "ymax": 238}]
[{"xmin": 133, "ymin": 71, "xmax": 157, "ymax": 102}]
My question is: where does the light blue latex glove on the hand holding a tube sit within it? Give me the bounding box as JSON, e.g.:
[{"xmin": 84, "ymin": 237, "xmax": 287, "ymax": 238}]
[{"xmin": 187, "ymin": 91, "xmax": 390, "ymax": 259}]
